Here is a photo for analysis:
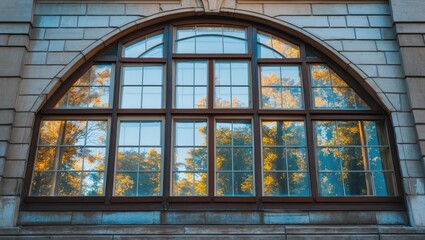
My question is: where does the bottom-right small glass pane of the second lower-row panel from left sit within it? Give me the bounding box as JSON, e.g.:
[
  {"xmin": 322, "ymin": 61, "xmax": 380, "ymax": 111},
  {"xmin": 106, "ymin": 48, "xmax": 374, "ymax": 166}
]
[{"xmin": 138, "ymin": 172, "xmax": 161, "ymax": 196}]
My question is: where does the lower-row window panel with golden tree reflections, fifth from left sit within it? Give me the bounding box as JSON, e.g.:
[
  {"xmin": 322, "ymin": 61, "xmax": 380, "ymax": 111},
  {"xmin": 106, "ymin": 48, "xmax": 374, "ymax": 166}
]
[{"xmin": 261, "ymin": 120, "xmax": 310, "ymax": 196}]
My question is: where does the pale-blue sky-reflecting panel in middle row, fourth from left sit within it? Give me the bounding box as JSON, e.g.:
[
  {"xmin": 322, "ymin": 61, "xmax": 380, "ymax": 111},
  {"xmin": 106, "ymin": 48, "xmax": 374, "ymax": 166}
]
[{"xmin": 214, "ymin": 61, "xmax": 251, "ymax": 108}]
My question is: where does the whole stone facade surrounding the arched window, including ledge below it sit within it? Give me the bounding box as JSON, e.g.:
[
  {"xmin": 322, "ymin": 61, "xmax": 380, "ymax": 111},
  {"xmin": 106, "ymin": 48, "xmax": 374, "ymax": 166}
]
[{"xmin": 0, "ymin": 0, "xmax": 425, "ymax": 239}]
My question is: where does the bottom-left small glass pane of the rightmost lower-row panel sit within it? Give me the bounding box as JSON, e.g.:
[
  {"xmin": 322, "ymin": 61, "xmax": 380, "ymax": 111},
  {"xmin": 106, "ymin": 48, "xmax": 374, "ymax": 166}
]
[{"xmin": 319, "ymin": 173, "xmax": 344, "ymax": 196}]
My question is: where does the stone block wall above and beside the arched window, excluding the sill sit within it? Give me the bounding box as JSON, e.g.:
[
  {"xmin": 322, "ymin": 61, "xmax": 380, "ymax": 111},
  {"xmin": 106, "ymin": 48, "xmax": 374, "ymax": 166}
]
[{"xmin": 0, "ymin": 0, "xmax": 425, "ymax": 229}]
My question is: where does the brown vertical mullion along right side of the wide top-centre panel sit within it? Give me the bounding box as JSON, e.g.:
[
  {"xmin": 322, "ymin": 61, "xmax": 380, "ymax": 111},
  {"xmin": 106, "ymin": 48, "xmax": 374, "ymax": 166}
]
[{"xmin": 248, "ymin": 26, "xmax": 263, "ymax": 202}]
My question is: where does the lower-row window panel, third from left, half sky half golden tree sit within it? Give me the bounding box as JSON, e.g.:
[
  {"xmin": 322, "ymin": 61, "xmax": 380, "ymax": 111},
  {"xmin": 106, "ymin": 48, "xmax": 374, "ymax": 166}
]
[{"xmin": 172, "ymin": 120, "xmax": 208, "ymax": 196}]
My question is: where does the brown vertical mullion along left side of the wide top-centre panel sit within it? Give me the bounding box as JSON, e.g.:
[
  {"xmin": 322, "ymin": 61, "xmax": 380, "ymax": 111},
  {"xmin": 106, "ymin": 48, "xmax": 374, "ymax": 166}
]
[{"xmin": 163, "ymin": 24, "xmax": 173, "ymax": 209}]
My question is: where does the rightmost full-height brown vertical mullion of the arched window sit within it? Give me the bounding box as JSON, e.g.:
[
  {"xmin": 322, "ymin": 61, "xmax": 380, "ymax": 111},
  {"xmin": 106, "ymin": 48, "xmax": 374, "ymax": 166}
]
[{"xmin": 300, "ymin": 43, "xmax": 319, "ymax": 201}]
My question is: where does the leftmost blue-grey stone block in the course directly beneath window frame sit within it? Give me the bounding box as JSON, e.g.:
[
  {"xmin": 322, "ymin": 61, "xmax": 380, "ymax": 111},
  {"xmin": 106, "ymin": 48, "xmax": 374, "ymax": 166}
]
[{"xmin": 18, "ymin": 211, "xmax": 72, "ymax": 226}]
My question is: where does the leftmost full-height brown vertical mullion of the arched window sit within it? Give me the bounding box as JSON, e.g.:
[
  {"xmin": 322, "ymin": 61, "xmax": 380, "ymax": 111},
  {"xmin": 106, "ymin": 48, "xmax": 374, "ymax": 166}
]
[{"xmin": 105, "ymin": 43, "xmax": 123, "ymax": 204}]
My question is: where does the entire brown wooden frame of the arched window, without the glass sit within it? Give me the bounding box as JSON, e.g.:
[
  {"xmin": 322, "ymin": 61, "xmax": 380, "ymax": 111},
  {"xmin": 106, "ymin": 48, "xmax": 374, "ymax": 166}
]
[{"xmin": 21, "ymin": 18, "xmax": 405, "ymax": 211}]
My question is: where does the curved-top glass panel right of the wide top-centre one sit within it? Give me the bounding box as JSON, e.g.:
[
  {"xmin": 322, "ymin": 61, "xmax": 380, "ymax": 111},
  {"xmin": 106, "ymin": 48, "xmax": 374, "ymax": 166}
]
[{"xmin": 257, "ymin": 31, "xmax": 300, "ymax": 58}]
